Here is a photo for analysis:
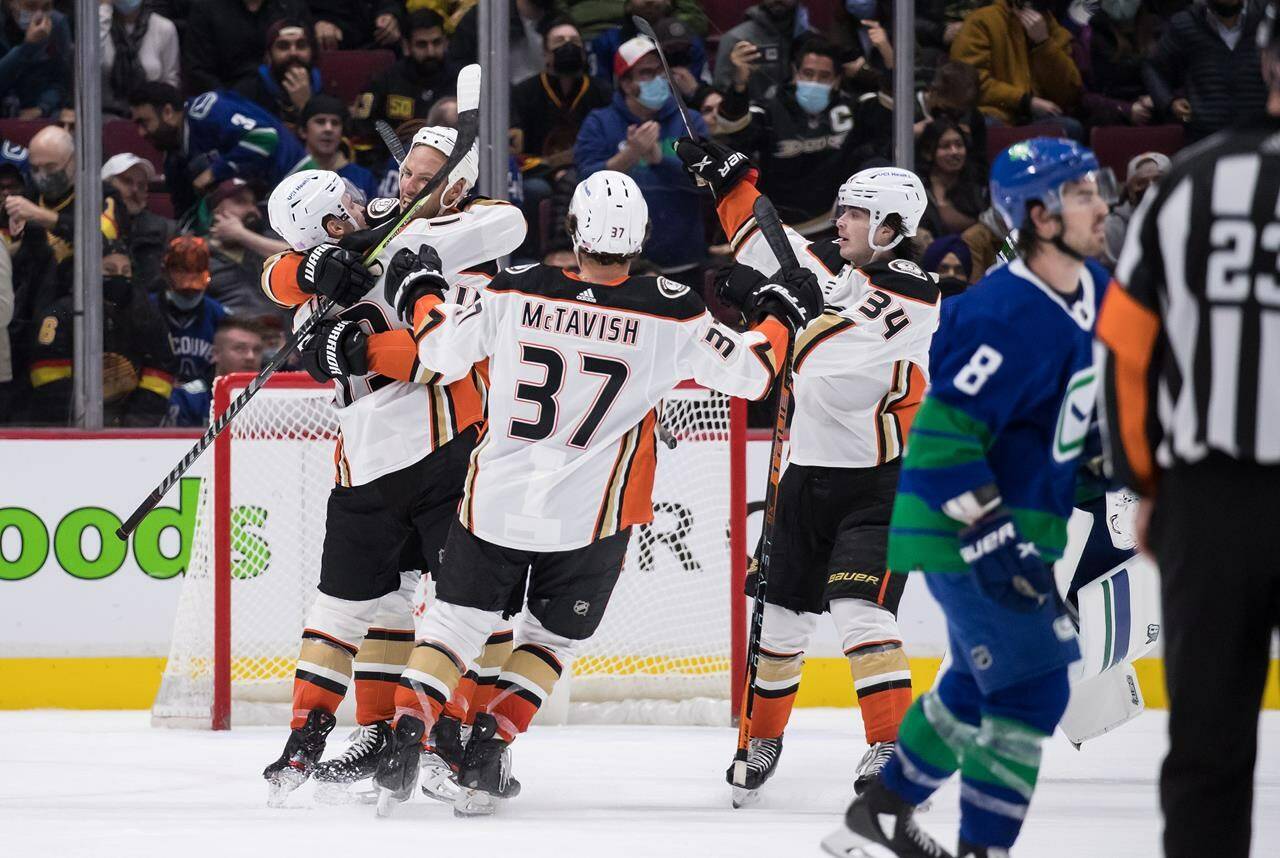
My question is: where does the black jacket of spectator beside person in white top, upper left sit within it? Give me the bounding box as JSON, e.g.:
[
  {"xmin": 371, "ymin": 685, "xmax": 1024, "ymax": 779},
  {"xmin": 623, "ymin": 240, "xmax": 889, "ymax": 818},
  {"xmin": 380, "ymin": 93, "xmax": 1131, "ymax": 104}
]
[{"xmin": 182, "ymin": 0, "xmax": 310, "ymax": 95}]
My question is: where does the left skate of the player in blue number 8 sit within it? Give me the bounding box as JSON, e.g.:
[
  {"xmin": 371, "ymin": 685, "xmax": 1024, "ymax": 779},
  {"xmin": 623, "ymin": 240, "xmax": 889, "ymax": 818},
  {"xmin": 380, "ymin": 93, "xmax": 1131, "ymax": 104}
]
[{"xmin": 822, "ymin": 777, "xmax": 952, "ymax": 858}]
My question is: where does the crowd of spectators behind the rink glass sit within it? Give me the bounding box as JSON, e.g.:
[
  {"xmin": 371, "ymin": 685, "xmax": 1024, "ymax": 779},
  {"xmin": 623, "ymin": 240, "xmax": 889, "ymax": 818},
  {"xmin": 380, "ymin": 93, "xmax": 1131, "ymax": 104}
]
[{"xmin": 0, "ymin": 0, "xmax": 1266, "ymax": 425}]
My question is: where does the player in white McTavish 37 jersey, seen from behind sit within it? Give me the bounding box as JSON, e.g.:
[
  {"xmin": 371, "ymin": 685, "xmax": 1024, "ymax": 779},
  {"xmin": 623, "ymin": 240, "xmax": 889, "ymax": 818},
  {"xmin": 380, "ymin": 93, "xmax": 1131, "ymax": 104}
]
[{"xmin": 363, "ymin": 170, "xmax": 822, "ymax": 814}]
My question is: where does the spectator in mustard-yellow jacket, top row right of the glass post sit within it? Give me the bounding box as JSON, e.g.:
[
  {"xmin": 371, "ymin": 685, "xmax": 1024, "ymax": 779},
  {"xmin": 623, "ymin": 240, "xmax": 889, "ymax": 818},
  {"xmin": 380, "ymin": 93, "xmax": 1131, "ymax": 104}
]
[{"xmin": 951, "ymin": 0, "xmax": 1084, "ymax": 140}]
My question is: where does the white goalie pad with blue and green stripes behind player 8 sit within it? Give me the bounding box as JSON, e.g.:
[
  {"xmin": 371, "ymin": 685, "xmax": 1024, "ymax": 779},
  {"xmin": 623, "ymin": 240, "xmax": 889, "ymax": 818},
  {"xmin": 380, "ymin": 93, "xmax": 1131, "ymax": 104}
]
[{"xmin": 1071, "ymin": 554, "xmax": 1161, "ymax": 684}]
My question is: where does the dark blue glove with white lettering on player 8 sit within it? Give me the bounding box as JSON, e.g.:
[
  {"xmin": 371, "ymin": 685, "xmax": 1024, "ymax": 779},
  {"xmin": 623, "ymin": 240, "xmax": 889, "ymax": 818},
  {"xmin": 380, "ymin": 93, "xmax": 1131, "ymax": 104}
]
[{"xmin": 960, "ymin": 508, "xmax": 1056, "ymax": 613}]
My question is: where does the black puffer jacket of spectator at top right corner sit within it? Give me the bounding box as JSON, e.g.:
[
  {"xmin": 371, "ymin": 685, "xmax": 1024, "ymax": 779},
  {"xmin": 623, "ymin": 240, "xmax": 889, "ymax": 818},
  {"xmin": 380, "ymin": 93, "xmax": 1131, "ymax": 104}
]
[{"xmin": 1143, "ymin": 4, "xmax": 1267, "ymax": 140}]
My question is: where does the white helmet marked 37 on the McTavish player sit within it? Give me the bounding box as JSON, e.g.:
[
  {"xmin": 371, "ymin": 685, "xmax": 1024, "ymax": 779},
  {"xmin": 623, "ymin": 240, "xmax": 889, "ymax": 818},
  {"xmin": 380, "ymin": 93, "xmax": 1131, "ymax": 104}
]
[{"xmin": 568, "ymin": 170, "xmax": 649, "ymax": 256}]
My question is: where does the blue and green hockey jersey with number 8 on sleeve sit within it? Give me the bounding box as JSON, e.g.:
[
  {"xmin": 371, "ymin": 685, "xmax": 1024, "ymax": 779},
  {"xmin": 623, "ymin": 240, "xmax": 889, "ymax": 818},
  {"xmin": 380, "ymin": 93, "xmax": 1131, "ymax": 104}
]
[{"xmin": 888, "ymin": 260, "xmax": 1110, "ymax": 572}]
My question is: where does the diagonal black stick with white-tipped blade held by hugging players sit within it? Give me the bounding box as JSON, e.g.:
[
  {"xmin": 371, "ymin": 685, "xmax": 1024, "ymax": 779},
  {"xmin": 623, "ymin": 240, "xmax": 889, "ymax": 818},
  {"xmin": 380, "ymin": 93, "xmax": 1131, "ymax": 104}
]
[{"xmin": 115, "ymin": 64, "xmax": 480, "ymax": 540}]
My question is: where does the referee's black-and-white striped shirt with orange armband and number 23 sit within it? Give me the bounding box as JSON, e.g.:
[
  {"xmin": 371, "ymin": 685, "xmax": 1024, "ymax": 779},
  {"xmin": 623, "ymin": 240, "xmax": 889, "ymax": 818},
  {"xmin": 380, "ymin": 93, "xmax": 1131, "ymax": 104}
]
[{"xmin": 1097, "ymin": 127, "xmax": 1280, "ymax": 493}]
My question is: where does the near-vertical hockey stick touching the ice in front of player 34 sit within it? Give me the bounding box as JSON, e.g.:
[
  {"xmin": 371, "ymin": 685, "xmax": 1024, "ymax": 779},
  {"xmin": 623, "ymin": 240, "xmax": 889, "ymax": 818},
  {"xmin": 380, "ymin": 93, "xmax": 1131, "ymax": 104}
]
[{"xmin": 733, "ymin": 196, "xmax": 800, "ymax": 807}]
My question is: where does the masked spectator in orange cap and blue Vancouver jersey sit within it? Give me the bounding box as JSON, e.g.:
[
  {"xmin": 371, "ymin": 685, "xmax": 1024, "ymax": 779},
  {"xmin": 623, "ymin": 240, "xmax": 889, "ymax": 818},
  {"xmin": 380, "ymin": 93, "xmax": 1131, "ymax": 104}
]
[{"xmin": 152, "ymin": 236, "xmax": 227, "ymax": 384}]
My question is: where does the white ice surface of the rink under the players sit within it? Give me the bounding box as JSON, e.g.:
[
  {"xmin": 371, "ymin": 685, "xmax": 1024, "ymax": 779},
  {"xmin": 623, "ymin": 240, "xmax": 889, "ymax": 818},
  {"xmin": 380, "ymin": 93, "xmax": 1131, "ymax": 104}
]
[{"xmin": 0, "ymin": 709, "xmax": 1280, "ymax": 858}]
